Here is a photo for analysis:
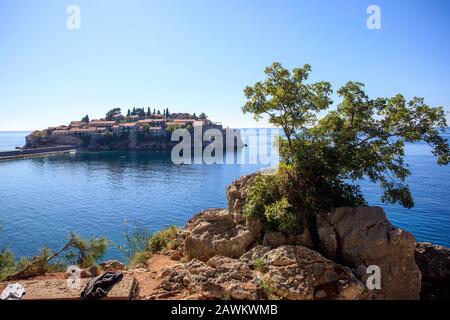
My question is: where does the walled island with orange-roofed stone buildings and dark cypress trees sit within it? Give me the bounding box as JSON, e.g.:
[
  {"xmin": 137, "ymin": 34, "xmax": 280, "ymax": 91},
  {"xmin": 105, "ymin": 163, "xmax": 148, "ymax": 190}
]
[{"xmin": 21, "ymin": 108, "xmax": 242, "ymax": 151}]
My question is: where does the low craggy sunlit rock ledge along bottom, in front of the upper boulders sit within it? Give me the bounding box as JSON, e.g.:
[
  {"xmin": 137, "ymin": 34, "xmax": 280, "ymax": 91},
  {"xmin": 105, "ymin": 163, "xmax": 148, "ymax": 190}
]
[{"xmin": 156, "ymin": 246, "xmax": 369, "ymax": 300}]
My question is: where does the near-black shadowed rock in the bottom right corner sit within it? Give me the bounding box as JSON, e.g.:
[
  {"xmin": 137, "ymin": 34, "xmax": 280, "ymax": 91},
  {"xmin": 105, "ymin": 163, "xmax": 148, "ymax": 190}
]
[{"xmin": 414, "ymin": 242, "xmax": 450, "ymax": 300}]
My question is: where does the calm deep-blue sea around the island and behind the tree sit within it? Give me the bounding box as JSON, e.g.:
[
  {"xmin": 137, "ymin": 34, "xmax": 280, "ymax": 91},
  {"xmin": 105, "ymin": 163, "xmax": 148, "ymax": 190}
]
[{"xmin": 0, "ymin": 132, "xmax": 450, "ymax": 258}]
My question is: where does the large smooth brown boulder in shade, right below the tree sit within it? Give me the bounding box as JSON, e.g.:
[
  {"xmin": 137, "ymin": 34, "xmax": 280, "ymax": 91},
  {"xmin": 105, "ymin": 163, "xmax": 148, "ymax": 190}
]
[{"xmin": 317, "ymin": 207, "xmax": 421, "ymax": 299}]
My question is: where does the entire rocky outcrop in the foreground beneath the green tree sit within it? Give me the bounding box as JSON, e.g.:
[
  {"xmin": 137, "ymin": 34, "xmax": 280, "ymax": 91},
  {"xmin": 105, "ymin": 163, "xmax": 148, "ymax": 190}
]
[{"xmin": 142, "ymin": 175, "xmax": 450, "ymax": 300}]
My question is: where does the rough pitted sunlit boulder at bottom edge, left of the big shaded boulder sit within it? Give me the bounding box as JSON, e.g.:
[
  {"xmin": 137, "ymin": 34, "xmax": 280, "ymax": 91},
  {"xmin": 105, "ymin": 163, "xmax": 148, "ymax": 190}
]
[{"xmin": 240, "ymin": 246, "xmax": 369, "ymax": 300}]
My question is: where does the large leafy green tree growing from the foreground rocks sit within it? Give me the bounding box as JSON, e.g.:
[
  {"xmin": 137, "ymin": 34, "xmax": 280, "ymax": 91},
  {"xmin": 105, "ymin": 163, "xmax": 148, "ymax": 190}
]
[{"xmin": 242, "ymin": 63, "xmax": 450, "ymax": 238}]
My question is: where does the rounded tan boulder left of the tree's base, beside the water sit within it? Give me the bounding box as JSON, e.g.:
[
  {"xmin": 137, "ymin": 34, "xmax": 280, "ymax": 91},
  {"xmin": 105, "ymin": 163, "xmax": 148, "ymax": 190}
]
[{"xmin": 184, "ymin": 209, "xmax": 262, "ymax": 261}]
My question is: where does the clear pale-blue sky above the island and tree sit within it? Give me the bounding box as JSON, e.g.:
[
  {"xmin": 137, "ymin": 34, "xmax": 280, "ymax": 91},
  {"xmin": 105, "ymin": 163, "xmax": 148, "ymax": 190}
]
[{"xmin": 0, "ymin": 0, "xmax": 450, "ymax": 130}]
